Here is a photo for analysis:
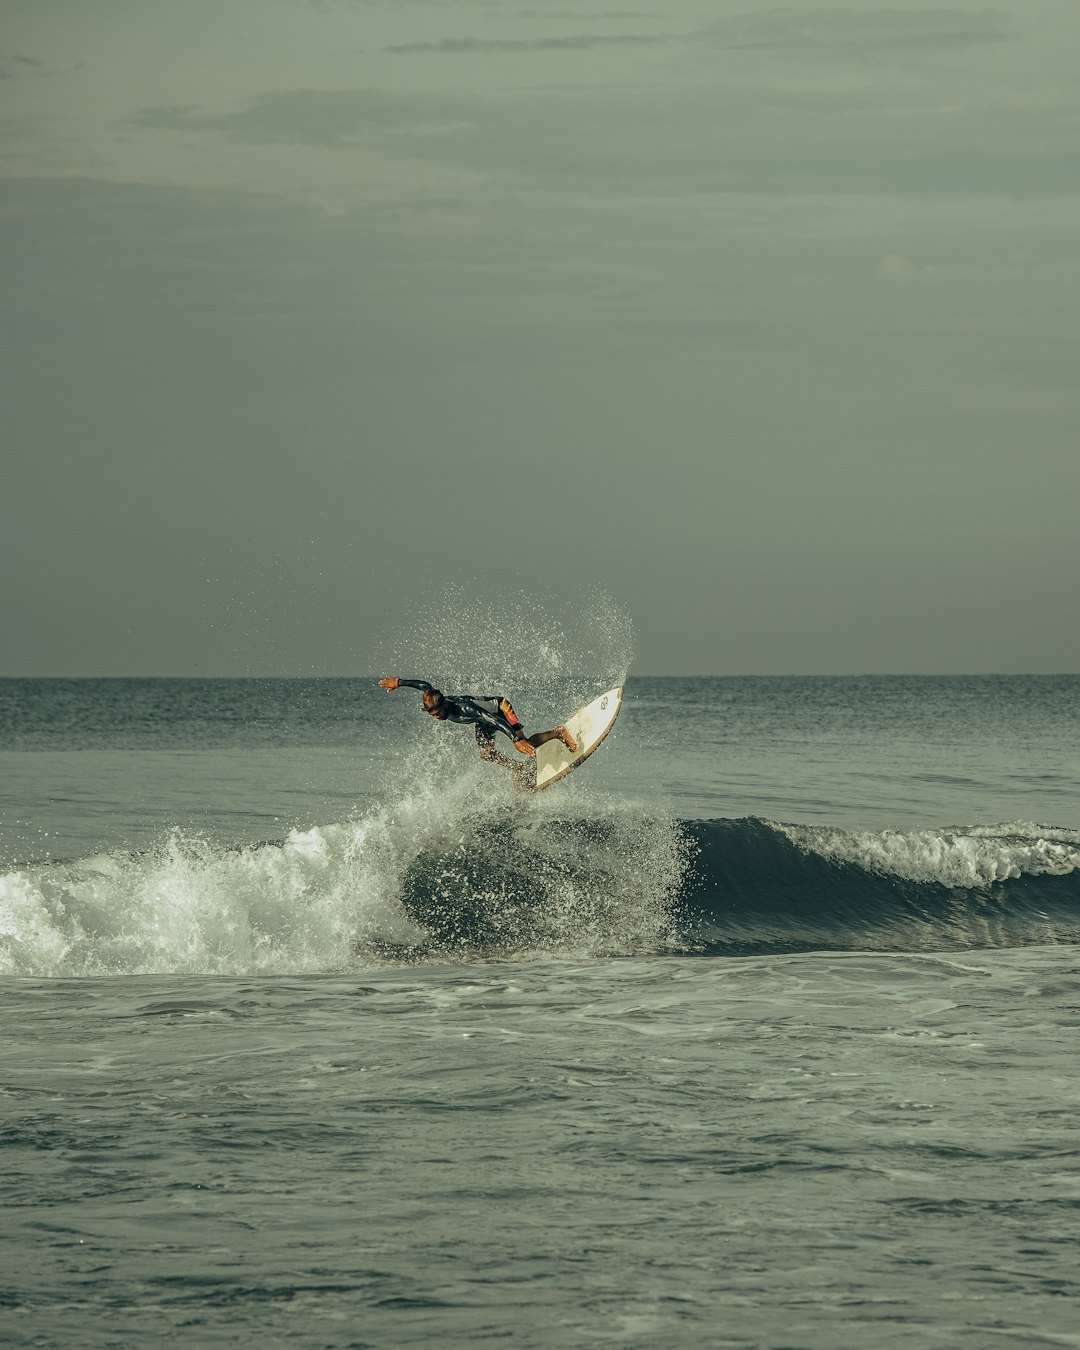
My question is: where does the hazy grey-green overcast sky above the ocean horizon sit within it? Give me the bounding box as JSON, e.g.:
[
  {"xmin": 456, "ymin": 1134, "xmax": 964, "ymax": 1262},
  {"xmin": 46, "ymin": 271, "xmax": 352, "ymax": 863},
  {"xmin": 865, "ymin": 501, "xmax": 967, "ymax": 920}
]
[{"xmin": 0, "ymin": 0, "xmax": 1080, "ymax": 675}]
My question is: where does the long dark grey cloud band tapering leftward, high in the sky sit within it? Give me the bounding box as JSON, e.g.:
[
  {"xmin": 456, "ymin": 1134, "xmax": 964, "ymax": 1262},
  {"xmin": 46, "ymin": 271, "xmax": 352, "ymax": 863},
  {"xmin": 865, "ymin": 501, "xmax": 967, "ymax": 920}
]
[{"xmin": 135, "ymin": 81, "xmax": 1080, "ymax": 198}]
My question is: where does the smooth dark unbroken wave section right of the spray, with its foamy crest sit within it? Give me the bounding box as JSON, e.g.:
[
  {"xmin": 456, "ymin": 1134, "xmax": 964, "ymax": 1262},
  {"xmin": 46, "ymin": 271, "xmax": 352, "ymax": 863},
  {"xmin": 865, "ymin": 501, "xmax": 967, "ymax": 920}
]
[{"xmin": 682, "ymin": 818, "xmax": 1080, "ymax": 956}]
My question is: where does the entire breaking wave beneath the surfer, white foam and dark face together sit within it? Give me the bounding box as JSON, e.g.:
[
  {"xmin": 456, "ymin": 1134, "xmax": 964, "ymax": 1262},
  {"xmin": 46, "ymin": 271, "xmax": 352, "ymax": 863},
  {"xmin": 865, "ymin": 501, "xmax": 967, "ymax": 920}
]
[{"xmin": 0, "ymin": 776, "xmax": 1080, "ymax": 976}]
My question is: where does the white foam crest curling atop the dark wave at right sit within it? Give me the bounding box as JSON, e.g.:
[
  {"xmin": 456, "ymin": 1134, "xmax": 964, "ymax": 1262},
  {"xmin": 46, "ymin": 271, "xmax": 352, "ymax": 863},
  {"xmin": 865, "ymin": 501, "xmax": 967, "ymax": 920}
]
[{"xmin": 775, "ymin": 821, "xmax": 1080, "ymax": 887}]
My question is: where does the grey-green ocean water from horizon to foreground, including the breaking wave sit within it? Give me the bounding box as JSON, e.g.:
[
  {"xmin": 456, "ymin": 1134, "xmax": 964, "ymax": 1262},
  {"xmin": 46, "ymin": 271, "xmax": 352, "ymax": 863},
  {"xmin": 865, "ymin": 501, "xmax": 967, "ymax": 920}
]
[{"xmin": 0, "ymin": 669, "xmax": 1080, "ymax": 1350}]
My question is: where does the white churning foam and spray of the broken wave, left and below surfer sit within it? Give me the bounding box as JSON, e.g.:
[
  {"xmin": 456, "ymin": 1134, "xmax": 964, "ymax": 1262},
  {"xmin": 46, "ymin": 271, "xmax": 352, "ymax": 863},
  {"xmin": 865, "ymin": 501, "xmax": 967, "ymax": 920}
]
[{"xmin": 0, "ymin": 755, "xmax": 684, "ymax": 976}]
